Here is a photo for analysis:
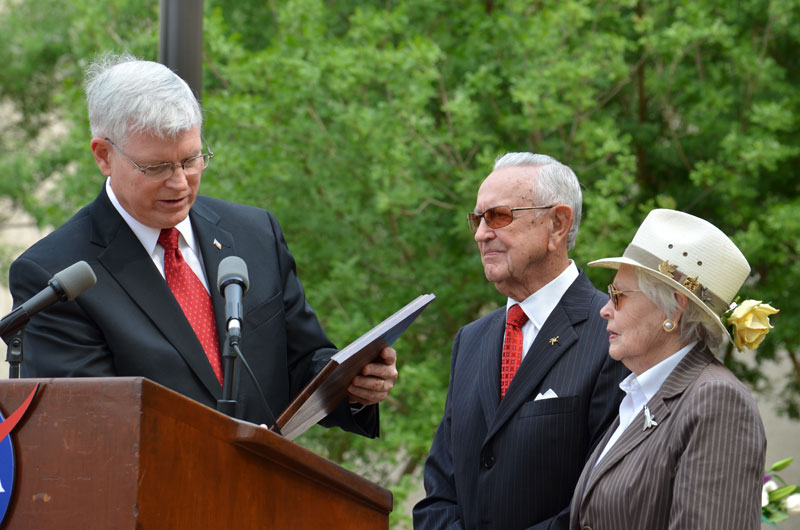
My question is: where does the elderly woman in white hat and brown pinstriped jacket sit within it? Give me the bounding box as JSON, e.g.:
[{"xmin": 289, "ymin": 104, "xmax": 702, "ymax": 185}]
[{"xmin": 570, "ymin": 210, "xmax": 775, "ymax": 530}]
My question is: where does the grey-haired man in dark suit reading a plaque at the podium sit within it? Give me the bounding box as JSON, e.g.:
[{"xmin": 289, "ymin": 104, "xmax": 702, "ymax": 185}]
[{"xmin": 9, "ymin": 55, "xmax": 397, "ymax": 437}]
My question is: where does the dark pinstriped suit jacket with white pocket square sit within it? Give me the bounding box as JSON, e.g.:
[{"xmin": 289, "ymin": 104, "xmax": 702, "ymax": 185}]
[{"xmin": 414, "ymin": 272, "xmax": 627, "ymax": 530}]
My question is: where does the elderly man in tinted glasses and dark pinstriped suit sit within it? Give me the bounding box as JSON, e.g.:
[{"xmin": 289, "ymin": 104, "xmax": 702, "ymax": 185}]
[{"xmin": 414, "ymin": 153, "xmax": 627, "ymax": 530}]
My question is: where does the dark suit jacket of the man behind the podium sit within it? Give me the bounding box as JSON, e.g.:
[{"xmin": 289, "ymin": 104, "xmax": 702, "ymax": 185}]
[{"xmin": 9, "ymin": 189, "xmax": 378, "ymax": 436}]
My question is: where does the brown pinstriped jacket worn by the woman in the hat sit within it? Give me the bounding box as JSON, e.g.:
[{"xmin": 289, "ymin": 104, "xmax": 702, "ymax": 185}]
[{"xmin": 570, "ymin": 348, "xmax": 766, "ymax": 530}]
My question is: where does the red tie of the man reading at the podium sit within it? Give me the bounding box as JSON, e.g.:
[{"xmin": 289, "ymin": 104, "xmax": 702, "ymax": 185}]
[{"xmin": 158, "ymin": 228, "xmax": 222, "ymax": 385}]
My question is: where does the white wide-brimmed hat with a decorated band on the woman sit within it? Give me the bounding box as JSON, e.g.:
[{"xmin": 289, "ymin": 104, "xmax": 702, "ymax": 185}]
[{"xmin": 589, "ymin": 209, "xmax": 750, "ymax": 334}]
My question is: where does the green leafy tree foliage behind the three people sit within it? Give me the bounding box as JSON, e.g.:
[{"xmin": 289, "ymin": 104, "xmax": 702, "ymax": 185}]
[{"xmin": 0, "ymin": 0, "xmax": 800, "ymax": 518}]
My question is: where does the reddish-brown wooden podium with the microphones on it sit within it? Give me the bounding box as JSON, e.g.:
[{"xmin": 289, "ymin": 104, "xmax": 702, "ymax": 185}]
[{"xmin": 0, "ymin": 377, "xmax": 392, "ymax": 530}]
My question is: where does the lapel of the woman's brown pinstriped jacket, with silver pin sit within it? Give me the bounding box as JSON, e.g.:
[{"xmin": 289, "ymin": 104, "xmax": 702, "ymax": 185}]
[{"xmin": 583, "ymin": 348, "xmax": 713, "ymax": 500}]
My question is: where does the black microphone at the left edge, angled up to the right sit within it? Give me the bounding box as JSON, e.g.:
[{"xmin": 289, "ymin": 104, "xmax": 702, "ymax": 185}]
[{"xmin": 0, "ymin": 261, "xmax": 97, "ymax": 340}]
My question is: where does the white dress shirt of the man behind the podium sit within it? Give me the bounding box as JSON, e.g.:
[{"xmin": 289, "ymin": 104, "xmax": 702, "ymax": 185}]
[{"xmin": 106, "ymin": 178, "xmax": 210, "ymax": 293}]
